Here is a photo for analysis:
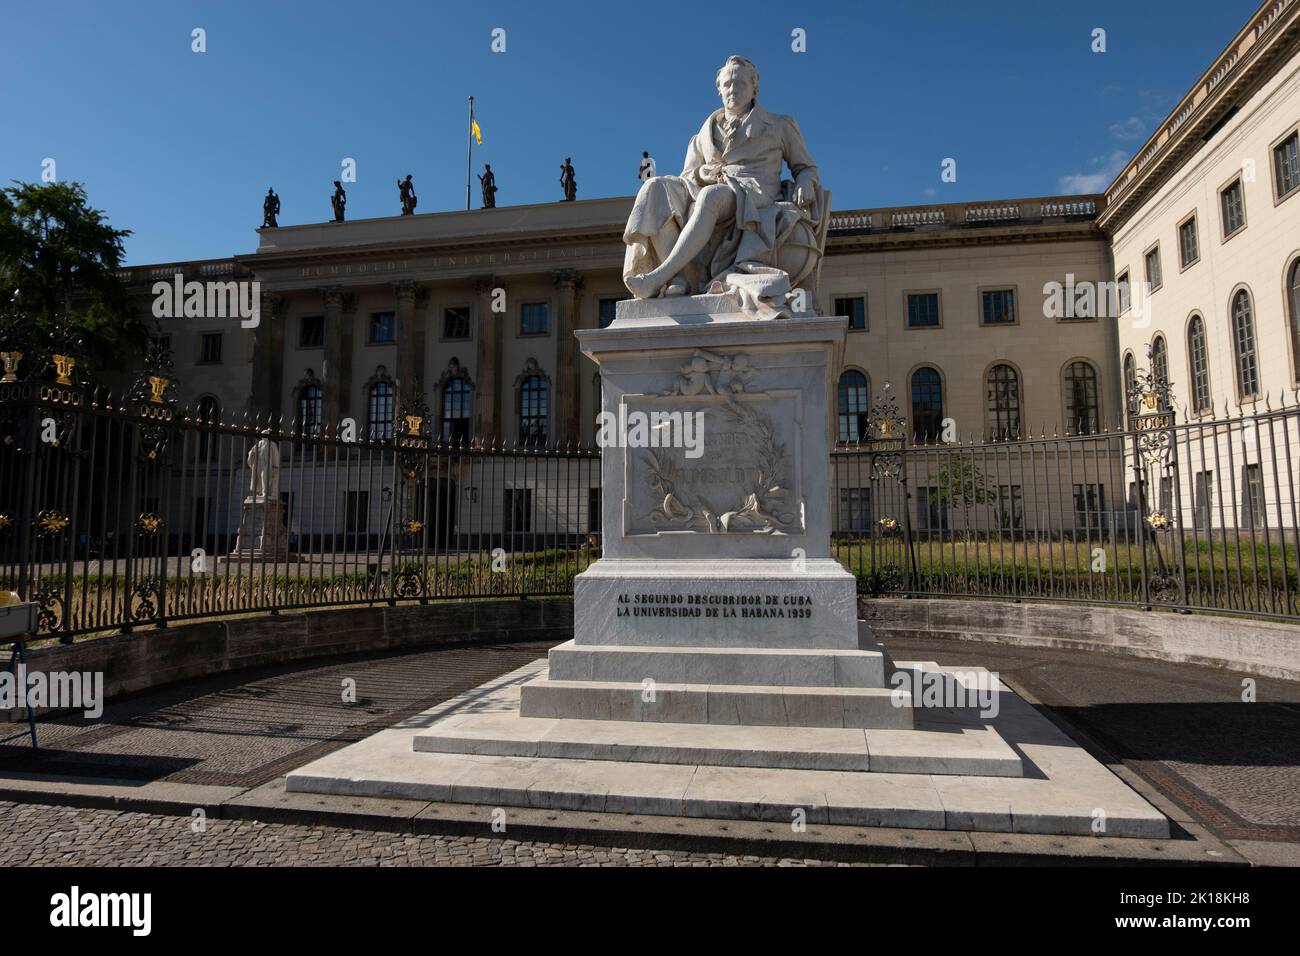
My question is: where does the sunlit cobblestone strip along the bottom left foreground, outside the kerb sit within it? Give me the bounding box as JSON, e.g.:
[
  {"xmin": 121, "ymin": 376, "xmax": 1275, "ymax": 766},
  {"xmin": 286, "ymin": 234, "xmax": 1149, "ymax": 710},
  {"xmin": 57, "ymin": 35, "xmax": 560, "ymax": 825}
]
[{"xmin": 0, "ymin": 801, "xmax": 873, "ymax": 866}]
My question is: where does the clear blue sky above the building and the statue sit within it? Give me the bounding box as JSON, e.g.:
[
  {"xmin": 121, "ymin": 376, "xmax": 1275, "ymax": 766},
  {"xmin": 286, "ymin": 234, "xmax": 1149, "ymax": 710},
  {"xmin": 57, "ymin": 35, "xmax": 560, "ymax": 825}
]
[{"xmin": 0, "ymin": 0, "xmax": 1257, "ymax": 263}]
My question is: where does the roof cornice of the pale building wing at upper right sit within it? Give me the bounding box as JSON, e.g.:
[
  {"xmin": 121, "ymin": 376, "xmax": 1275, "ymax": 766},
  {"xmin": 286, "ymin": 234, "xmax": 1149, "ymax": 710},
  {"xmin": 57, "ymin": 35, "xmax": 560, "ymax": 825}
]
[{"xmin": 1099, "ymin": 0, "xmax": 1300, "ymax": 234}]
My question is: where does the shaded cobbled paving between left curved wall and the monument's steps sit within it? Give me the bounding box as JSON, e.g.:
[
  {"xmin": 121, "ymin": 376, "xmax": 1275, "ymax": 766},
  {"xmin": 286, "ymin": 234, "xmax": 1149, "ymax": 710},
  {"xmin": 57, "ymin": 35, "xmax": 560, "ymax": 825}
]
[{"xmin": 0, "ymin": 641, "xmax": 550, "ymax": 787}]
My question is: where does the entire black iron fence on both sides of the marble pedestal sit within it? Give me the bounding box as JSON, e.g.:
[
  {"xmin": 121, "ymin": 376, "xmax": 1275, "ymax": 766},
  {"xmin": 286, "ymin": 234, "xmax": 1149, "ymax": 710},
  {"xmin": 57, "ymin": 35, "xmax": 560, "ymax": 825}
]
[{"xmin": 0, "ymin": 335, "xmax": 1300, "ymax": 641}]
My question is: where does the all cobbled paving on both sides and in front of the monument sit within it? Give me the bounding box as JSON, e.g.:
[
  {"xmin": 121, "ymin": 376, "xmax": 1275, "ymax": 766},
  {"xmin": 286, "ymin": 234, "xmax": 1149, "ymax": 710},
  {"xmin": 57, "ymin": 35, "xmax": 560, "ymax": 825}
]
[{"xmin": 0, "ymin": 629, "xmax": 1300, "ymax": 865}]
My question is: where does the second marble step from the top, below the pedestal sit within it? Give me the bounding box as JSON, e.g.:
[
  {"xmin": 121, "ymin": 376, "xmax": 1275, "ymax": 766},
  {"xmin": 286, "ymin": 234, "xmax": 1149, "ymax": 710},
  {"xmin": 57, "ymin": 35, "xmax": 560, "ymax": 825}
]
[{"xmin": 519, "ymin": 678, "xmax": 911, "ymax": 730}]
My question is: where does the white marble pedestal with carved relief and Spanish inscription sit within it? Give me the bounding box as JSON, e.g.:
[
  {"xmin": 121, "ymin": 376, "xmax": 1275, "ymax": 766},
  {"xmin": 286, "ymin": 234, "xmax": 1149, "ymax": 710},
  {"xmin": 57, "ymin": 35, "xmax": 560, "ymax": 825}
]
[{"xmin": 575, "ymin": 295, "xmax": 858, "ymax": 650}]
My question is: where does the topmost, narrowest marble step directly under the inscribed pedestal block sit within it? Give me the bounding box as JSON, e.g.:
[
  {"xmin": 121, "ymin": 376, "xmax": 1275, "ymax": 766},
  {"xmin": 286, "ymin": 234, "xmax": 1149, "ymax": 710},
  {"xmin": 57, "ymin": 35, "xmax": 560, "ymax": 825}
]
[{"xmin": 550, "ymin": 641, "xmax": 885, "ymax": 688}]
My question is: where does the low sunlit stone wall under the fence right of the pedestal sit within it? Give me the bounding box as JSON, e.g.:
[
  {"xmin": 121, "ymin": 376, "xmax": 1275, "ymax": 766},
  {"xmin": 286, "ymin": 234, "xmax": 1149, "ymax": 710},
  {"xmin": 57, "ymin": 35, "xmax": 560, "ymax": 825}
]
[{"xmin": 858, "ymin": 598, "xmax": 1300, "ymax": 680}]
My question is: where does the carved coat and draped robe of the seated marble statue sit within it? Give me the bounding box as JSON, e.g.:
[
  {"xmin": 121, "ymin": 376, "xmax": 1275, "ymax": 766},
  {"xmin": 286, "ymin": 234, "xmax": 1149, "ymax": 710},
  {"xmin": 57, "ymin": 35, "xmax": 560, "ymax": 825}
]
[{"xmin": 623, "ymin": 103, "xmax": 818, "ymax": 316}]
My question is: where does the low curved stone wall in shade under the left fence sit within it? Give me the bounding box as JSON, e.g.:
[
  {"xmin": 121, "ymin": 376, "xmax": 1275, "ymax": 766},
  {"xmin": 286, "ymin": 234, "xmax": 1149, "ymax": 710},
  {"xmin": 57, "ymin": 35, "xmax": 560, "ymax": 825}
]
[{"xmin": 8, "ymin": 600, "xmax": 573, "ymax": 719}]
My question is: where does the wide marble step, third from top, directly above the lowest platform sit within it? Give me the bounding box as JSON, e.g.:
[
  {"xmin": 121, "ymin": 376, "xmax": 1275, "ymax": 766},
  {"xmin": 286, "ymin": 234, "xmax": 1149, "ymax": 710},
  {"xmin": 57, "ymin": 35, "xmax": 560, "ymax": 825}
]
[{"xmin": 412, "ymin": 714, "xmax": 1023, "ymax": 777}]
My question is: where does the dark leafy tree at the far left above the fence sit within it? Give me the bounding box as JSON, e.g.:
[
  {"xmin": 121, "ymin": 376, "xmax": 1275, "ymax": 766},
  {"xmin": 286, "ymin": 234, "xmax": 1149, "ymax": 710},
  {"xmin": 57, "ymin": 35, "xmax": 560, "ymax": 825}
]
[{"xmin": 0, "ymin": 182, "xmax": 148, "ymax": 367}]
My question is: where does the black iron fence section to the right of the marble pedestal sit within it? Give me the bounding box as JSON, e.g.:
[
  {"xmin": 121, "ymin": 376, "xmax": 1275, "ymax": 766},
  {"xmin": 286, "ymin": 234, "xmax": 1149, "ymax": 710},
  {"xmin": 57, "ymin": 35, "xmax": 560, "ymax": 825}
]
[{"xmin": 832, "ymin": 373, "xmax": 1300, "ymax": 619}]
